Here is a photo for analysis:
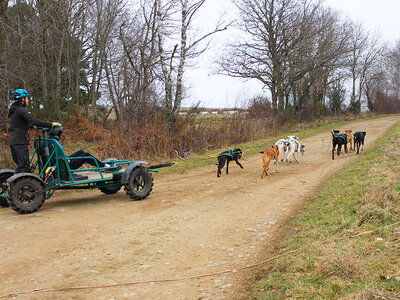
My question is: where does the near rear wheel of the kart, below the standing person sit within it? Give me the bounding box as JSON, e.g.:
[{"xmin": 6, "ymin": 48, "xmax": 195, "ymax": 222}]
[{"xmin": 7, "ymin": 176, "xmax": 46, "ymax": 214}]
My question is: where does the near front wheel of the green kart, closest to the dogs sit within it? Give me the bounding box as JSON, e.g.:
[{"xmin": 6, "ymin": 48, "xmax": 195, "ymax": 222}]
[{"xmin": 125, "ymin": 167, "xmax": 153, "ymax": 200}]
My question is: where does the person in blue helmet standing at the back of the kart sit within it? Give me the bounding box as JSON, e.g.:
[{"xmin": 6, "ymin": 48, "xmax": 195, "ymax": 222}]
[{"xmin": 8, "ymin": 89, "xmax": 62, "ymax": 173}]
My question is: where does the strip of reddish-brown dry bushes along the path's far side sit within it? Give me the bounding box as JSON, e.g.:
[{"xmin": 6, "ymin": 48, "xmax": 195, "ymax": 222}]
[{"xmin": 75, "ymin": 112, "xmax": 368, "ymax": 161}]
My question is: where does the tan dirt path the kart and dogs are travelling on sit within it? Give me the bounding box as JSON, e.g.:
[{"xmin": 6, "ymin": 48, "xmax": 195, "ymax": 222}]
[{"xmin": 0, "ymin": 116, "xmax": 400, "ymax": 299}]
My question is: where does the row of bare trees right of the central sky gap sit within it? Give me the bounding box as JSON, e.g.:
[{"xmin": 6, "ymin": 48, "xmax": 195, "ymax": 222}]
[{"xmin": 220, "ymin": 0, "xmax": 400, "ymax": 120}]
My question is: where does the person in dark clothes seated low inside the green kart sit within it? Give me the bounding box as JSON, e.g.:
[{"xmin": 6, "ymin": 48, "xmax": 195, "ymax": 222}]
[{"xmin": 49, "ymin": 127, "xmax": 122, "ymax": 172}]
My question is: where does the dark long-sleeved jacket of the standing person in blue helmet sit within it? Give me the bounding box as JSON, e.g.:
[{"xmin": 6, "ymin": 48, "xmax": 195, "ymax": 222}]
[{"xmin": 8, "ymin": 101, "xmax": 51, "ymax": 145}]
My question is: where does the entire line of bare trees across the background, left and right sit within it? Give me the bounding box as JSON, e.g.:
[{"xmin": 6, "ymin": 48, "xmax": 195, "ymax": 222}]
[{"xmin": 0, "ymin": 0, "xmax": 400, "ymax": 130}]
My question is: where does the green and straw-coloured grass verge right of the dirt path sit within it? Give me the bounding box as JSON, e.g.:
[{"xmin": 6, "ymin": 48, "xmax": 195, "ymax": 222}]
[{"xmin": 247, "ymin": 122, "xmax": 400, "ymax": 299}]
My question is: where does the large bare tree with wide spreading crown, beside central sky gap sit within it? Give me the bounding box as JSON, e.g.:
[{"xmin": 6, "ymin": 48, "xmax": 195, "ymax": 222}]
[{"xmin": 221, "ymin": 0, "xmax": 347, "ymax": 116}]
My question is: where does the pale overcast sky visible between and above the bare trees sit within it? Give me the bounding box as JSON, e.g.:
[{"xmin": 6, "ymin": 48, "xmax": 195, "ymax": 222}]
[{"xmin": 184, "ymin": 0, "xmax": 400, "ymax": 108}]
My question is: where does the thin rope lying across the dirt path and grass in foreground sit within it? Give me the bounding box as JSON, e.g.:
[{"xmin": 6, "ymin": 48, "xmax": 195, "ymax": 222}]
[{"xmin": 0, "ymin": 221, "xmax": 400, "ymax": 299}]
